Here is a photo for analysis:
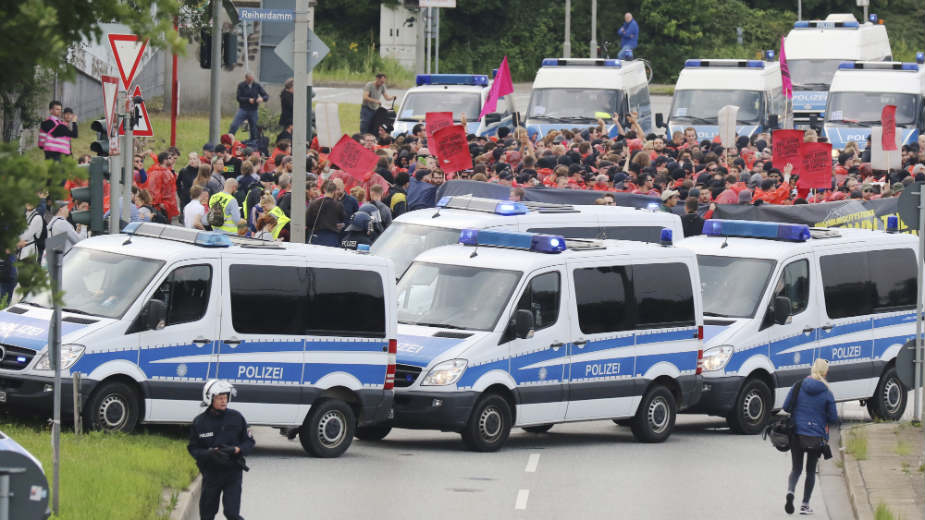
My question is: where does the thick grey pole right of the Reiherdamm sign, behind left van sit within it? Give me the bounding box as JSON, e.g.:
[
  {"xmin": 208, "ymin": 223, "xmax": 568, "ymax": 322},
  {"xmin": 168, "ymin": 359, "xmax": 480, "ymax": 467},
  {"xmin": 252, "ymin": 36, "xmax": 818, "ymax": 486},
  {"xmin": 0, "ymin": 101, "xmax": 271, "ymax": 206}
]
[{"xmin": 290, "ymin": 0, "xmax": 311, "ymax": 244}]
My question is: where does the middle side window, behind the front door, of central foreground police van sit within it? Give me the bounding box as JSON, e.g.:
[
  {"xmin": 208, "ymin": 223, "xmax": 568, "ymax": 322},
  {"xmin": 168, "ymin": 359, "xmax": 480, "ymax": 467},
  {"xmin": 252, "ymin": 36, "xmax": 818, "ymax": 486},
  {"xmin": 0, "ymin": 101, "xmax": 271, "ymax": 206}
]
[{"xmin": 574, "ymin": 266, "xmax": 632, "ymax": 334}]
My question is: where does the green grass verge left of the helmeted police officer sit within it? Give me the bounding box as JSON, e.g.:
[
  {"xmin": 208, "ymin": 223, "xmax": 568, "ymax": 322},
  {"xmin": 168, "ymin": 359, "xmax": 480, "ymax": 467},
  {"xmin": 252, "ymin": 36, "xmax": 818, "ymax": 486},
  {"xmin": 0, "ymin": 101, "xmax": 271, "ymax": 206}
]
[{"xmin": 0, "ymin": 418, "xmax": 198, "ymax": 520}]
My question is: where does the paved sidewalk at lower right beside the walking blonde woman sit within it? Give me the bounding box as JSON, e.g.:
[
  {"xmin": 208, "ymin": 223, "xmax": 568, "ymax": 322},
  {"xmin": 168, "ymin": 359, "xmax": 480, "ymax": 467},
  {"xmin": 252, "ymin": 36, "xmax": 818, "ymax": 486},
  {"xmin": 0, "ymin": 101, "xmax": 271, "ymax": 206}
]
[{"xmin": 841, "ymin": 421, "xmax": 925, "ymax": 520}]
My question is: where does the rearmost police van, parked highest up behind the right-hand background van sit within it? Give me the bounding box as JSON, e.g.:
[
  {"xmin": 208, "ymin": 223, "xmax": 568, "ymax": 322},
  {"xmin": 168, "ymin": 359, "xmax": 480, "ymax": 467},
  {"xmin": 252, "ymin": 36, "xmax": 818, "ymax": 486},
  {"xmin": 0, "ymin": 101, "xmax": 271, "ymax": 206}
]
[{"xmin": 784, "ymin": 14, "xmax": 893, "ymax": 128}]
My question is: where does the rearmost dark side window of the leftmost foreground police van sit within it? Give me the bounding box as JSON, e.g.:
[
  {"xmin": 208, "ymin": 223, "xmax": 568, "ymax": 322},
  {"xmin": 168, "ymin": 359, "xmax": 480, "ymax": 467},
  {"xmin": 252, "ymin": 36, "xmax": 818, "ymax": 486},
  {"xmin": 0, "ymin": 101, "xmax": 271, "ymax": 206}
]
[{"xmin": 303, "ymin": 267, "xmax": 385, "ymax": 338}]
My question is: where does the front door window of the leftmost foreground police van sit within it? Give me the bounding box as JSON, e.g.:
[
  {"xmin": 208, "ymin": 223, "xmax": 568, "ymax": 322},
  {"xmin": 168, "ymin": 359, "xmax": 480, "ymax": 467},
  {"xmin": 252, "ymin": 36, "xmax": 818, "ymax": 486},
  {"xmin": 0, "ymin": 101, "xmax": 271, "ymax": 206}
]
[{"xmin": 151, "ymin": 265, "xmax": 212, "ymax": 327}]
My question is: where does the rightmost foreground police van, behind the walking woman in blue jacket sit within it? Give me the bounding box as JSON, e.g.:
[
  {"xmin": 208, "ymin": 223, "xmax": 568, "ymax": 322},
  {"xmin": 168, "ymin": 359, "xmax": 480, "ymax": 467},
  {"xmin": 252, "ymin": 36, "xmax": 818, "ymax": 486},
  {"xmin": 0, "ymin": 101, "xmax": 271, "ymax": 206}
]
[{"xmin": 680, "ymin": 217, "xmax": 920, "ymax": 434}]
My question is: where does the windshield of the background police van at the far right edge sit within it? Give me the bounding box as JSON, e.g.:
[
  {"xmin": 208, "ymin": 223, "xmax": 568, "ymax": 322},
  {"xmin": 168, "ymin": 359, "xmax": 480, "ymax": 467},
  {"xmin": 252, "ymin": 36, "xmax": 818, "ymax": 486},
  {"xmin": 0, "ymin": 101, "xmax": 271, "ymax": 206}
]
[{"xmin": 825, "ymin": 92, "xmax": 919, "ymax": 126}]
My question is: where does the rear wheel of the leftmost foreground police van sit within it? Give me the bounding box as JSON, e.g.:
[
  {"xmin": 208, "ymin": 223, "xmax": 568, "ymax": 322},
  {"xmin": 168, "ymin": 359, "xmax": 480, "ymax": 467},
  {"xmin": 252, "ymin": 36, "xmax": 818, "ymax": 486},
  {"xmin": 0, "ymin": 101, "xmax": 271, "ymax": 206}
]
[{"xmin": 299, "ymin": 399, "xmax": 356, "ymax": 459}]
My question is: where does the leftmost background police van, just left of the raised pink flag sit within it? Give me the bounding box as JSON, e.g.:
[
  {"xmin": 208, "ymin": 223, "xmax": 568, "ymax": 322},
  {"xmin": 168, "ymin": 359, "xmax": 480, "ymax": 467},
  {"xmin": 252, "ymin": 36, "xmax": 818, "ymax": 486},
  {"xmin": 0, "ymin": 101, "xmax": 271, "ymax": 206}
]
[{"xmin": 392, "ymin": 74, "xmax": 514, "ymax": 137}]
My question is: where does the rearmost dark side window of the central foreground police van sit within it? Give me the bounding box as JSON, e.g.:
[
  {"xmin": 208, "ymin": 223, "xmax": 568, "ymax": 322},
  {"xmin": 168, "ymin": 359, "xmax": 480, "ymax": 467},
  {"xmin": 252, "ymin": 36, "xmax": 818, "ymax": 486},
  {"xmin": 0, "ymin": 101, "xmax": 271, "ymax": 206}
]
[{"xmin": 633, "ymin": 263, "xmax": 696, "ymax": 329}]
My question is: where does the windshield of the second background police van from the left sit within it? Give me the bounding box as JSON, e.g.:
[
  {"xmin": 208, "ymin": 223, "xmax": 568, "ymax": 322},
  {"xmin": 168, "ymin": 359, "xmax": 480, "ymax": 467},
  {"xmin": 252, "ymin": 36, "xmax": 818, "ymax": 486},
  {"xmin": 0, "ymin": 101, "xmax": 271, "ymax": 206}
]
[{"xmin": 527, "ymin": 88, "xmax": 624, "ymax": 122}]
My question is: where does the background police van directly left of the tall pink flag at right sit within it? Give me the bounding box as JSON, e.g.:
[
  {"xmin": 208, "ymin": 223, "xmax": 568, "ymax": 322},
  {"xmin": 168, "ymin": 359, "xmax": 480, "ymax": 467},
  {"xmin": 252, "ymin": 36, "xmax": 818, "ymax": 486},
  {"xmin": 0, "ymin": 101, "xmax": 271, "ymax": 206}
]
[{"xmin": 659, "ymin": 59, "xmax": 787, "ymax": 140}]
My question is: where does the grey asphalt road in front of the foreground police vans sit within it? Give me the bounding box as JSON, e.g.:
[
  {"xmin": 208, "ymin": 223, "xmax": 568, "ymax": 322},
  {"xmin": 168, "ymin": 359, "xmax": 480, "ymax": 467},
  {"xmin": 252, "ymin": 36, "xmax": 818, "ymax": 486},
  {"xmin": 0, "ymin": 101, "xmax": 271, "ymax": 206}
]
[{"xmin": 226, "ymin": 395, "xmax": 911, "ymax": 520}]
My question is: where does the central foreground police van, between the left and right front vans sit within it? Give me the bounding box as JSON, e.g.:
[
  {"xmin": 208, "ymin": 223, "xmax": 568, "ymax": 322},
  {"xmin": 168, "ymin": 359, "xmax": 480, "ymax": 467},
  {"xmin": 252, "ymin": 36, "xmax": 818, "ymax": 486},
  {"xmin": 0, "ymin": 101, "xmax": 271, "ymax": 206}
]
[{"xmin": 366, "ymin": 229, "xmax": 702, "ymax": 451}]
